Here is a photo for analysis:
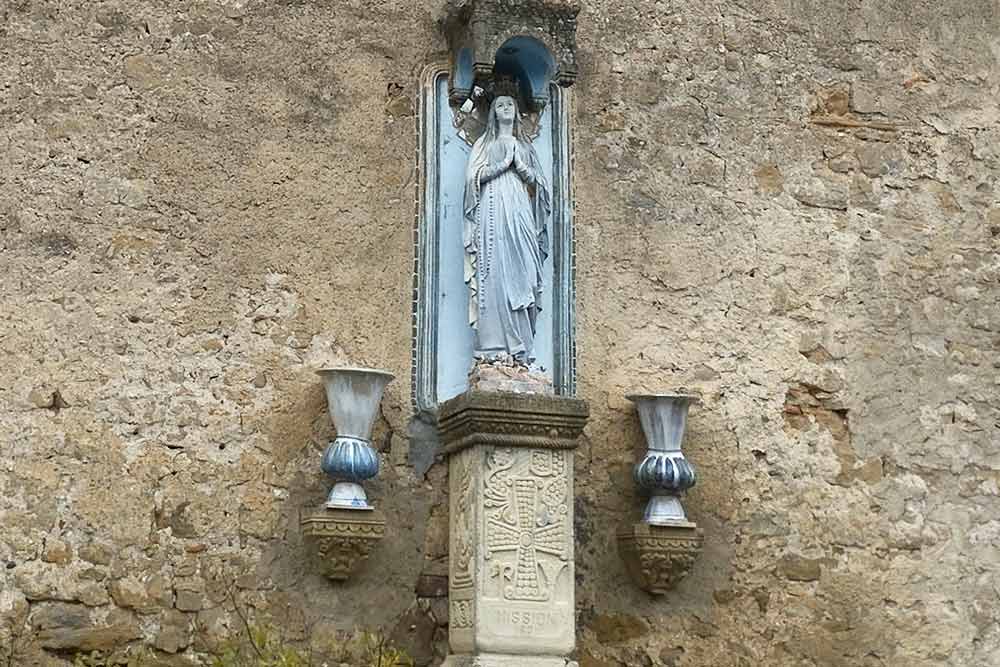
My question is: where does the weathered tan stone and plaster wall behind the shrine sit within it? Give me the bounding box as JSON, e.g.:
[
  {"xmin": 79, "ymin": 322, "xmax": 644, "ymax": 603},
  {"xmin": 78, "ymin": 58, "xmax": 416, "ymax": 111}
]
[{"xmin": 0, "ymin": 0, "xmax": 1000, "ymax": 667}]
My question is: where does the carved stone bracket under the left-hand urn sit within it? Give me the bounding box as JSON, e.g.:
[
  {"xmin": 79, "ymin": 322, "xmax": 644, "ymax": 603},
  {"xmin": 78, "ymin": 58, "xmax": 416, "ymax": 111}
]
[{"xmin": 301, "ymin": 509, "xmax": 385, "ymax": 581}]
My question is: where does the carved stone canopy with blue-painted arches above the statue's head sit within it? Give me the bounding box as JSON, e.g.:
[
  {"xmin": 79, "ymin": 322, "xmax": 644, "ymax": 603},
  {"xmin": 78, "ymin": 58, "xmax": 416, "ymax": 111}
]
[{"xmin": 443, "ymin": 0, "xmax": 580, "ymax": 111}]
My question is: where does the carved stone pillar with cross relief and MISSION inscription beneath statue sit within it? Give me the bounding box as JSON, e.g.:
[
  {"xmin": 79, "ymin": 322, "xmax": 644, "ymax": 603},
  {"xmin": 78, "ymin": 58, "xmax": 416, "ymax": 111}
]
[{"xmin": 438, "ymin": 390, "xmax": 588, "ymax": 667}]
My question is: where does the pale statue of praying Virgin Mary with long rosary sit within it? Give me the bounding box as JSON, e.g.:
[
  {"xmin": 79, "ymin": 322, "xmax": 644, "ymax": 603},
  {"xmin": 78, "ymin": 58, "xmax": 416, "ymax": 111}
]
[{"xmin": 463, "ymin": 95, "xmax": 552, "ymax": 366}]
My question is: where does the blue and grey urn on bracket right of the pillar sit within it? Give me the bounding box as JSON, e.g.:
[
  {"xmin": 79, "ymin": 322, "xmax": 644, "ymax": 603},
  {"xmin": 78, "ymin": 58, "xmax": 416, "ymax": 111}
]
[{"xmin": 626, "ymin": 394, "xmax": 698, "ymax": 526}]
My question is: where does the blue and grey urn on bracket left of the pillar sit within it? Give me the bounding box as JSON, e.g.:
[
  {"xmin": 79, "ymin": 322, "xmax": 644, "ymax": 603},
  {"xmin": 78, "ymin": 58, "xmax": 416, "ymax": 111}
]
[{"xmin": 316, "ymin": 368, "xmax": 394, "ymax": 510}]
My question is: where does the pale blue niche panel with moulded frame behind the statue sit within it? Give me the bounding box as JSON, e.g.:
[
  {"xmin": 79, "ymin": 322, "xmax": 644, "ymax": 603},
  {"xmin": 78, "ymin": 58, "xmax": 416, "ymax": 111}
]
[{"xmin": 413, "ymin": 66, "xmax": 575, "ymax": 413}]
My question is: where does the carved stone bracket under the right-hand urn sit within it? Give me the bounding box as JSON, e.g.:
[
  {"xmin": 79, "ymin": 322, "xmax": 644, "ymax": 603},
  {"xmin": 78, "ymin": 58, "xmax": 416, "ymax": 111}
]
[{"xmin": 618, "ymin": 522, "xmax": 704, "ymax": 595}]
